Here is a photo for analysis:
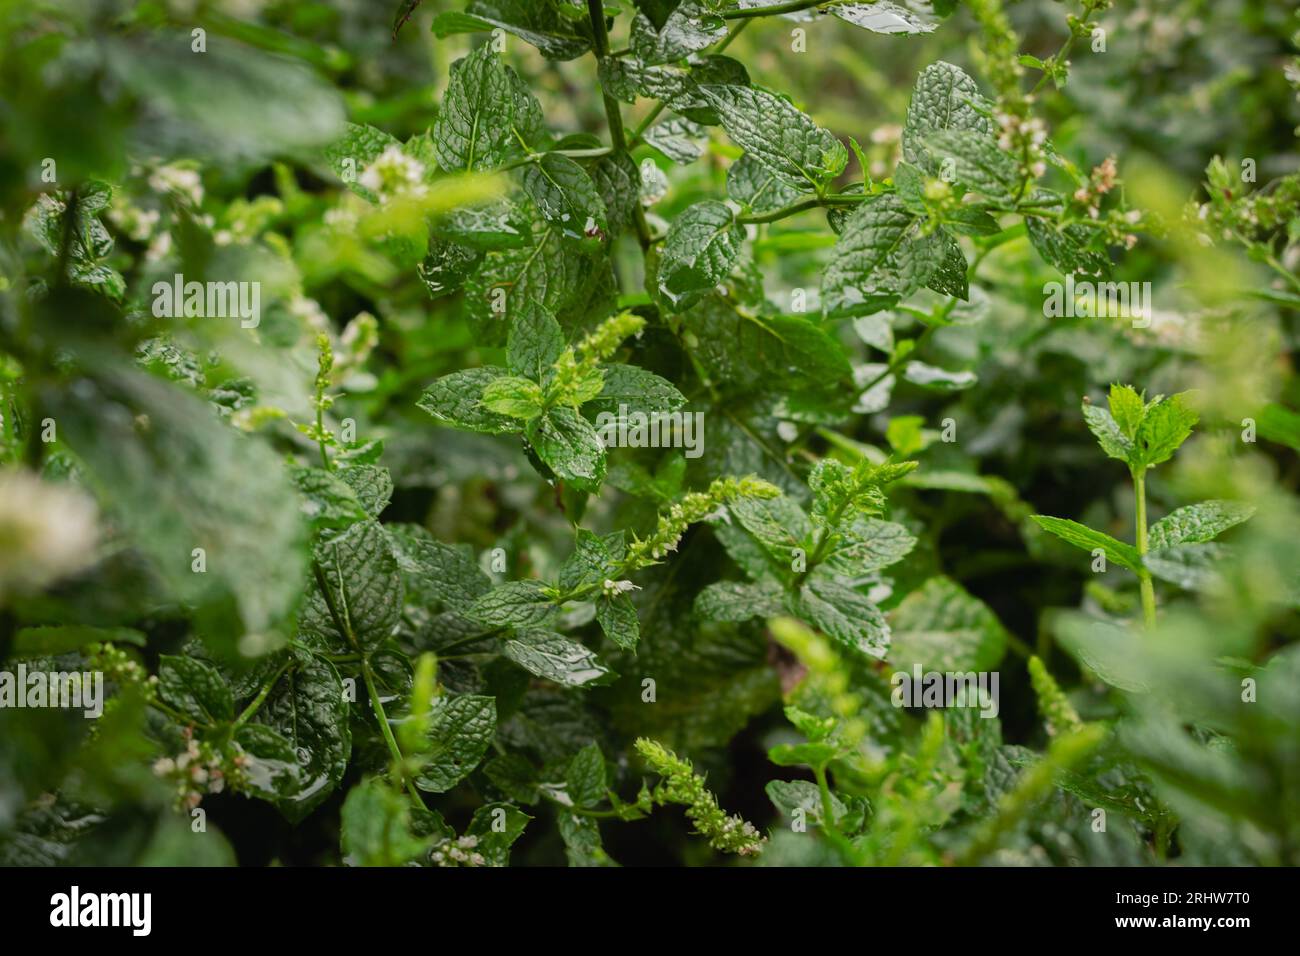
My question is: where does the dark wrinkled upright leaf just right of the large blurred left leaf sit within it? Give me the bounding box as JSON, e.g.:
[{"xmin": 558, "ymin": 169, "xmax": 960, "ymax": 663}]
[{"xmin": 298, "ymin": 519, "xmax": 404, "ymax": 653}]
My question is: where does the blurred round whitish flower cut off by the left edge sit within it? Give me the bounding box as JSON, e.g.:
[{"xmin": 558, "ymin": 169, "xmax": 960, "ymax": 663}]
[{"xmin": 0, "ymin": 470, "xmax": 99, "ymax": 596}]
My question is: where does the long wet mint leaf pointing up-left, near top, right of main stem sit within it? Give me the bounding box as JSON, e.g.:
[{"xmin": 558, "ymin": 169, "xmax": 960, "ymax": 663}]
[{"xmin": 699, "ymin": 86, "xmax": 849, "ymax": 193}]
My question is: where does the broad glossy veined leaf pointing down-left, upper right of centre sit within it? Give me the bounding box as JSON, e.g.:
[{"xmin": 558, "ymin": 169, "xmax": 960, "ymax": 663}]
[{"xmin": 822, "ymin": 194, "xmax": 939, "ymax": 317}]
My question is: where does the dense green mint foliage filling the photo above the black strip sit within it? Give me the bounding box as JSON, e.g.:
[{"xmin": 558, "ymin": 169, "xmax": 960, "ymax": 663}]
[{"xmin": 0, "ymin": 0, "xmax": 1300, "ymax": 865}]
